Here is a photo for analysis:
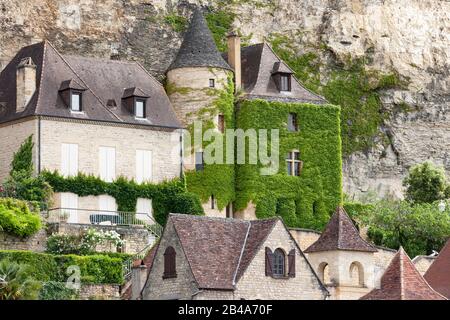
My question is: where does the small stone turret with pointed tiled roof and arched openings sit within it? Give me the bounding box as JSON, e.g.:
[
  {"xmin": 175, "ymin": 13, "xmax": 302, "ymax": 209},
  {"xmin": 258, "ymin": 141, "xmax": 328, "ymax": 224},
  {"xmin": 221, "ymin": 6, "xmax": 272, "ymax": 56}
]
[{"xmin": 305, "ymin": 207, "xmax": 378, "ymax": 300}]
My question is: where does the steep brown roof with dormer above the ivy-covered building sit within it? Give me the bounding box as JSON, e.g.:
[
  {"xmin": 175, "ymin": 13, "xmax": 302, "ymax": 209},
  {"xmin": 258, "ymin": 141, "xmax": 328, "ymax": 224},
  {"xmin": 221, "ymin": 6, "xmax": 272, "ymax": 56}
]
[{"xmin": 222, "ymin": 42, "xmax": 328, "ymax": 104}]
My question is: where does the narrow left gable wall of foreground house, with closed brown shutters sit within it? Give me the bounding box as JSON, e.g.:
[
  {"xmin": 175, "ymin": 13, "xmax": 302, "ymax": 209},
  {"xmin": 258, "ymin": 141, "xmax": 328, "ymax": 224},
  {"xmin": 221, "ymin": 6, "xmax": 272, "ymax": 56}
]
[{"xmin": 142, "ymin": 220, "xmax": 198, "ymax": 300}]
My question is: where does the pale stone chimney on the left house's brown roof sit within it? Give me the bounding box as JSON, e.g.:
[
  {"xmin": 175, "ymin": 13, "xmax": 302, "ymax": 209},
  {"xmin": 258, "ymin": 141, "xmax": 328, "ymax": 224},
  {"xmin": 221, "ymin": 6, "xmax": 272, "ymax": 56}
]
[{"xmin": 16, "ymin": 57, "xmax": 36, "ymax": 112}]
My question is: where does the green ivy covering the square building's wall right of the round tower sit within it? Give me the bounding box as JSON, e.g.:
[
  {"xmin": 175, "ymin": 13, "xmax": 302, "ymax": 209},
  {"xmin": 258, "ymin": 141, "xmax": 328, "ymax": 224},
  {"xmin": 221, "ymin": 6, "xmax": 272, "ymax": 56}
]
[{"xmin": 235, "ymin": 100, "xmax": 342, "ymax": 229}]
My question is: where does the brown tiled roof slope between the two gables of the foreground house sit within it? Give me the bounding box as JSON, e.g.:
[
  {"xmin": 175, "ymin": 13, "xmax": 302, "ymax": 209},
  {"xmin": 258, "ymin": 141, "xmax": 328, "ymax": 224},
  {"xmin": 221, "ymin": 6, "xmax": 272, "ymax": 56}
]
[{"xmin": 169, "ymin": 214, "xmax": 279, "ymax": 290}]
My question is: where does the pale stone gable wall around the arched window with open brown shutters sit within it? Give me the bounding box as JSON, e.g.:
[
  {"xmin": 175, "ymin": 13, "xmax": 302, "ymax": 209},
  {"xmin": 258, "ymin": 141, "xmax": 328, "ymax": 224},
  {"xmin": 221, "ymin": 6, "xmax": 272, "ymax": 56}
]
[{"xmin": 234, "ymin": 221, "xmax": 327, "ymax": 300}]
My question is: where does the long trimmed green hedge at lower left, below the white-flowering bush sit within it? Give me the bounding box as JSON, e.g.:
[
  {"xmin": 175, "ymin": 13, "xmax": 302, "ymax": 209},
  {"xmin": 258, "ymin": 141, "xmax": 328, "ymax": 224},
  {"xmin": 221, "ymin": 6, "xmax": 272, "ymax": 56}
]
[{"xmin": 0, "ymin": 250, "xmax": 124, "ymax": 284}]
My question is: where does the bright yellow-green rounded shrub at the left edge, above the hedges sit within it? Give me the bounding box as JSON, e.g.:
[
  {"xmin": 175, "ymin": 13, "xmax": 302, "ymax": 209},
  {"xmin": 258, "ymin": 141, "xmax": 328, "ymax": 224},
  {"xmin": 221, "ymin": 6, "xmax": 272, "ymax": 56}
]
[{"xmin": 0, "ymin": 198, "xmax": 42, "ymax": 237}]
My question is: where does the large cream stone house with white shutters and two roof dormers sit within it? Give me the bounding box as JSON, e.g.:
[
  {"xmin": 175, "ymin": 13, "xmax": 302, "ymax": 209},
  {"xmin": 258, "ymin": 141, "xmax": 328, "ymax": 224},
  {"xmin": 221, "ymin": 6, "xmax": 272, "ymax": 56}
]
[{"xmin": 0, "ymin": 41, "xmax": 181, "ymax": 224}]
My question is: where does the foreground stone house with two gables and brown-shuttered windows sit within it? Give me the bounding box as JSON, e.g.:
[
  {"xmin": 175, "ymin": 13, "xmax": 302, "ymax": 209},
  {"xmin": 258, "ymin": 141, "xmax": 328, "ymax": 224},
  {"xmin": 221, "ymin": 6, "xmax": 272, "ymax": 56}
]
[{"xmin": 139, "ymin": 214, "xmax": 328, "ymax": 300}]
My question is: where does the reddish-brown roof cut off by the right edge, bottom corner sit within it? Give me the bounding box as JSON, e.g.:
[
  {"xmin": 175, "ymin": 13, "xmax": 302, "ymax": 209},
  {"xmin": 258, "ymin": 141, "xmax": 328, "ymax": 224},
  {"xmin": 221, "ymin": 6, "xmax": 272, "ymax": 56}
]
[{"xmin": 424, "ymin": 239, "xmax": 450, "ymax": 299}]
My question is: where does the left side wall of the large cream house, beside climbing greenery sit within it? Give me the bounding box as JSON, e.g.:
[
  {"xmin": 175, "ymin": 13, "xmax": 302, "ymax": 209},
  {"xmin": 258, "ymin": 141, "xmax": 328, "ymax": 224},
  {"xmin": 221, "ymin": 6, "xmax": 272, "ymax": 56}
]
[{"xmin": 0, "ymin": 119, "xmax": 38, "ymax": 184}]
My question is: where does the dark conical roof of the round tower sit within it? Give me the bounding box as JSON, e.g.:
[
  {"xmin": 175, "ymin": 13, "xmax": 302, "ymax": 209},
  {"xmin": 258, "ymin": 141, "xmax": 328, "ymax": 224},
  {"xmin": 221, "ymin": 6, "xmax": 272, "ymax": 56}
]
[{"xmin": 167, "ymin": 8, "xmax": 232, "ymax": 71}]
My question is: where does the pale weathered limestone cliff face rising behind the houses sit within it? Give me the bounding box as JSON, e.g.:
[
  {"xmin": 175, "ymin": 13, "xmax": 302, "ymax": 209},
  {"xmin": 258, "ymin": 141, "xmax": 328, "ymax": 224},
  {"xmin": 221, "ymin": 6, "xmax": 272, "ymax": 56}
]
[{"xmin": 0, "ymin": 0, "xmax": 450, "ymax": 200}]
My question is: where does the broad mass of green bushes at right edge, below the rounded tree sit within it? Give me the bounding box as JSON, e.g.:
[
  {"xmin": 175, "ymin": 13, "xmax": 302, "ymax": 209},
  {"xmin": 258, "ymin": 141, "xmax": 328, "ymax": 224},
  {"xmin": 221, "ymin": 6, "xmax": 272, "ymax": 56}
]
[{"xmin": 361, "ymin": 201, "xmax": 450, "ymax": 257}]
